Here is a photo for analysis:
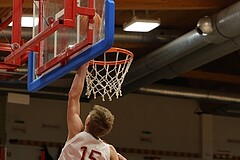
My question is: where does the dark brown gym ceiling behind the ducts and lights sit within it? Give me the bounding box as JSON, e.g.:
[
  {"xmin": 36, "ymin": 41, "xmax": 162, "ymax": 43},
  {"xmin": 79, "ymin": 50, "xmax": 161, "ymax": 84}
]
[{"xmin": 0, "ymin": 0, "xmax": 240, "ymax": 115}]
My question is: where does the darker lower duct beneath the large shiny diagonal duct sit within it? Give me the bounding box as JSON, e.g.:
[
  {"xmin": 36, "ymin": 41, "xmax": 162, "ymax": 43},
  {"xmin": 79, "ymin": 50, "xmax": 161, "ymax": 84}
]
[{"xmin": 122, "ymin": 36, "xmax": 240, "ymax": 94}]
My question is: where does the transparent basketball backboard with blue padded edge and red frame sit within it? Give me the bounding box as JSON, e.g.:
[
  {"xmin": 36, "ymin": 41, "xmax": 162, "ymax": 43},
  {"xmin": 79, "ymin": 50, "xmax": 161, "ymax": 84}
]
[{"xmin": 28, "ymin": 0, "xmax": 115, "ymax": 92}]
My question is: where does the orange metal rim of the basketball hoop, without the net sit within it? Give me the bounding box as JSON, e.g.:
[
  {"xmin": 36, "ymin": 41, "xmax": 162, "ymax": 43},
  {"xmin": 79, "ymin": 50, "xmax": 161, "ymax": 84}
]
[{"xmin": 89, "ymin": 47, "xmax": 134, "ymax": 65}]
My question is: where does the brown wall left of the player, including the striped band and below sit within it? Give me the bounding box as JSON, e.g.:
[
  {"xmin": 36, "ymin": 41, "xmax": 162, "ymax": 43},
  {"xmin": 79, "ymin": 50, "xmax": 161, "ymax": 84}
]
[{"xmin": 6, "ymin": 95, "xmax": 67, "ymax": 160}]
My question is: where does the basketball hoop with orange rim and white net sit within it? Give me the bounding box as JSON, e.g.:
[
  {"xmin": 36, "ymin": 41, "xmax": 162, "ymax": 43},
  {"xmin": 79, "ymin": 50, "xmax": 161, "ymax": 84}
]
[{"xmin": 86, "ymin": 47, "xmax": 133, "ymax": 101}]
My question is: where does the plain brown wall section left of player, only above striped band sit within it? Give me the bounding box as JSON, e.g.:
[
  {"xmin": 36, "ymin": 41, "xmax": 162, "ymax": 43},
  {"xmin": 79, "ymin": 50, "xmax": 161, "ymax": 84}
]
[{"xmin": 6, "ymin": 98, "xmax": 67, "ymax": 142}]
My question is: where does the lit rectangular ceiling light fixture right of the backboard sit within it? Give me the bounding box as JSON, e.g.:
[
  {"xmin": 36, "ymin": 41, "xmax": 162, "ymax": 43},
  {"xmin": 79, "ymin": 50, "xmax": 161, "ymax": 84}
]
[{"xmin": 123, "ymin": 17, "xmax": 160, "ymax": 32}]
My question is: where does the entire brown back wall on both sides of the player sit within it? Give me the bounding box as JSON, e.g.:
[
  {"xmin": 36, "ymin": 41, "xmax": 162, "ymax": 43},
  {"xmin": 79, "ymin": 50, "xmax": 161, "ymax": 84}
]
[{"xmin": 2, "ymin": 94, "xmax": 240, "ymax": 160}]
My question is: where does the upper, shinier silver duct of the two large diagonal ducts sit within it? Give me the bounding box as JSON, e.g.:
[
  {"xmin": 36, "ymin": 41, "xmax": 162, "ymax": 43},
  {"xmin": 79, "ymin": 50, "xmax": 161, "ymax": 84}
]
[{"xmin": 123, "ymin": 2, "xmax": 240, "ymax": 91}]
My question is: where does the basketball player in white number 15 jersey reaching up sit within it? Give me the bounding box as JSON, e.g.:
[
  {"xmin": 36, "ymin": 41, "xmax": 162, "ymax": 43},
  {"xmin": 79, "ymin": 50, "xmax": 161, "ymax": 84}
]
[{"xmin": 58, "ymin": 64, "xmax": 125, "ymax": 160}]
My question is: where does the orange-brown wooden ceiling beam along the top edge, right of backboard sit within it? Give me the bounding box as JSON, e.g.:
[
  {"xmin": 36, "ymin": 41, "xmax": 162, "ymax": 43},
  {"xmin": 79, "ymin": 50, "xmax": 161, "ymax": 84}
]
[{"xmin": 115, "ymin": 0, "xmax": 237, "ymax": 10}]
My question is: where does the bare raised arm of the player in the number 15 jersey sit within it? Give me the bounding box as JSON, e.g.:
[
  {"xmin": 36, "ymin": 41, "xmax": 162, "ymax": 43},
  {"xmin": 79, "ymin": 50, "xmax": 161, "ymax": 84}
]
[{"xmin": 67, "ymin": 64, "xmax": 88, "ymax": 140}]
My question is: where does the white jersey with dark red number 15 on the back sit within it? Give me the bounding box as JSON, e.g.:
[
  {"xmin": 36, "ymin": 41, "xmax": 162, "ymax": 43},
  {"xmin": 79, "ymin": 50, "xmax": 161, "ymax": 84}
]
[{"xmin": 58, "ymin": 132, "xmax": 110, "ymax": 160}]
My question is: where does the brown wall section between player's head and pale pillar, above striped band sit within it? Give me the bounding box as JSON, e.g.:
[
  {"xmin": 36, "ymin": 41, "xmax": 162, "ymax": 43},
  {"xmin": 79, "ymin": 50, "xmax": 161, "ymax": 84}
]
[{"xmin": 92, "ymin": 94, "xmax": 201, "ymax": 159}]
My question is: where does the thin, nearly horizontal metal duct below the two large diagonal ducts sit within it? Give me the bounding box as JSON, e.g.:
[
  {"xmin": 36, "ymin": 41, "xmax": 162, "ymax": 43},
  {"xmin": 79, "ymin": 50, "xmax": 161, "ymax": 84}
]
[{"xmin": 136, "ymin": 85, "xmax": 240, "ymax": 104}]
